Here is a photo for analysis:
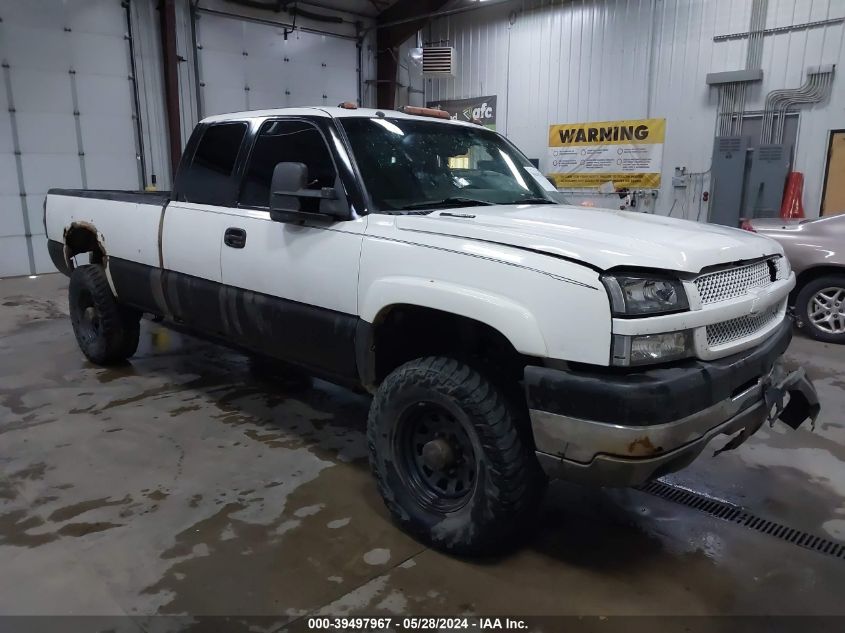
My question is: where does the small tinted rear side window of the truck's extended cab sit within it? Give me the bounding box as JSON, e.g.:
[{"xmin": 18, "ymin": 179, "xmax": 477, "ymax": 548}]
[{"xmin": 183, "ymin": 122, "xmax": 247, "ymax": 205}]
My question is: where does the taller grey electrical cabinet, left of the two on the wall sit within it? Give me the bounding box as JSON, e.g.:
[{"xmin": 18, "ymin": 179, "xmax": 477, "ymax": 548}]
[{"xmin": 709, "ymin": 136, "xmax": 748, "ymax": 227}]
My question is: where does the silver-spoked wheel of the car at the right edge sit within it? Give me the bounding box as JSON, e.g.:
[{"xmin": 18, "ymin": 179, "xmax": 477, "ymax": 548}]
[{"xmin": 795, "ymin": 275, "xmax": 845, "ymax": 344}]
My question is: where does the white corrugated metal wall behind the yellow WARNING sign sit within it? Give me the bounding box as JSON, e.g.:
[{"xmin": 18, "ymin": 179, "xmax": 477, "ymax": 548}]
[{"xmin": 408, "ymin": 0, "xmax": 845, "ymax": 218}]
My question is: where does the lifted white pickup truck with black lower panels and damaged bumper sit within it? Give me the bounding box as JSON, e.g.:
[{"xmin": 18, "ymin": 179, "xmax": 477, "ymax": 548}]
[{"xmin": 45, "ymin": 106, "xmax": 819, "ymax": 553}]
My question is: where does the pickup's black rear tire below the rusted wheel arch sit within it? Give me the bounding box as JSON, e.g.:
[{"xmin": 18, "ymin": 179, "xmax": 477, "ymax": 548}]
[{"xmin": 68, "ymin": 264, "xmax": 141, "ymax": 365}]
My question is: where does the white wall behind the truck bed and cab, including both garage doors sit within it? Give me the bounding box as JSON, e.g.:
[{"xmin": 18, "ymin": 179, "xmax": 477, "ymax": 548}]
[{"xmin": 0, "ymin": 0, "xmax": 375, "ymax": 278}]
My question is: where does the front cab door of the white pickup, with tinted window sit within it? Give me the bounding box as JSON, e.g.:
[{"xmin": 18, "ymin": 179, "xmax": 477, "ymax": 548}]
[{"xmin": 220, "ymin": 118, "xmax": 365, "ymax": 379}]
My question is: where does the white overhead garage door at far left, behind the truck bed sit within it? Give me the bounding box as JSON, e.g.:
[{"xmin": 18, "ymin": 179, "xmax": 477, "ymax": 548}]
[{"xmin": 0, "ymin": 0, "xmax": 140, "ymax": 277}]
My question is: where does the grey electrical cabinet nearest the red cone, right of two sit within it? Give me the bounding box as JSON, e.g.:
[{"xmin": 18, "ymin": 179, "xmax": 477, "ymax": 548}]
[{"xmin": 742, "ymin": 145, "xmax": 792, "ymax": 218}]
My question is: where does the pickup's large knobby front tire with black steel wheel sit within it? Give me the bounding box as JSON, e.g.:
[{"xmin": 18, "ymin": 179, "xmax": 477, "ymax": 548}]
[{"xmin": 367, "ymin": 357, "xmax": 545, "ymax": 554}]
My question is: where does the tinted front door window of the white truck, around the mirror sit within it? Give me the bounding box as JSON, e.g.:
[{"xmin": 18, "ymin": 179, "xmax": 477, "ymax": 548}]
[{"xmin": 239, "ymin": 116, "xmax": 337, "ymax": 211}]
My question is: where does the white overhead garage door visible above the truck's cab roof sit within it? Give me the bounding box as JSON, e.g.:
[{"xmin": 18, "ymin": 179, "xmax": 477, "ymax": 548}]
[{"xmin": 197, "ymin": 12, "xmax": 358, "ymax": 116}]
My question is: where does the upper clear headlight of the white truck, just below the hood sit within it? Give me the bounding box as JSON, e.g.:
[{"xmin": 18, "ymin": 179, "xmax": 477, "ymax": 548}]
[{"xmin": 601, "ymin": 275, "xmax": 689, "ymax": 316}]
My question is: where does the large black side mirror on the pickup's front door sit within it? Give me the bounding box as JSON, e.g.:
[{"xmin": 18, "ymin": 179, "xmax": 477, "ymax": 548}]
[{"xmin": 270, "ymin": 163, "xmax": 349, "ymax": 223}]
